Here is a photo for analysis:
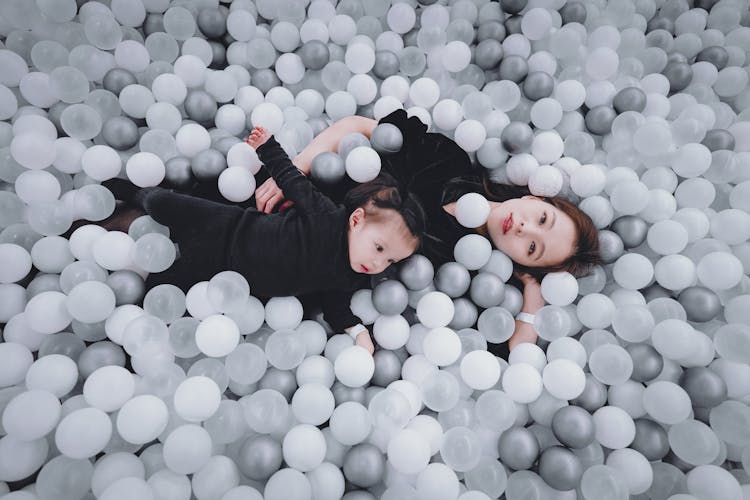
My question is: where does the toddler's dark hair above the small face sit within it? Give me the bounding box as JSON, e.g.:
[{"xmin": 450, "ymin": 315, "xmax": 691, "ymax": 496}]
[{"xmin": 344, "ymin": 172, "xmax": 427, "ymax": 244}]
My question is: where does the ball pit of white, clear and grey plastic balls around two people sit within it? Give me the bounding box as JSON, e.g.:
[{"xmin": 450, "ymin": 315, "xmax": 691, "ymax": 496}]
[{"xmin": 0, "ymin": 0, "xmax": 750, "ymax": 500}]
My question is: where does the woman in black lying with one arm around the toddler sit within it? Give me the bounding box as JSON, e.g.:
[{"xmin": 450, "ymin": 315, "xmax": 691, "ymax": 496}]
[{"xmin": 255, "ymin": 109, "xmax": 600, "ymax": 349}]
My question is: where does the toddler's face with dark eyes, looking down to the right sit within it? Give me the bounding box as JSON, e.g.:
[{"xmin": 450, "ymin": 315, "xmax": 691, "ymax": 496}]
[{"xmin": 349, "ymin": 208, "xmax": 417, "ymax": 274}]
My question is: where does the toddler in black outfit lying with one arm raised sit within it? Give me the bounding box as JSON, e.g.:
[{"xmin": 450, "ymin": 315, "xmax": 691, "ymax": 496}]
[{"xmin": 104, "ymin": 127, "xmax": 426, "ymax": 353}]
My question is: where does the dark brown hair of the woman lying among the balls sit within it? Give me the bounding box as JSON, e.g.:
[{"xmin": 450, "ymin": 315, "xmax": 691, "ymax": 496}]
[{"xmin": 482, "ymin": 175, "xmax": 602, "ymax": 280}]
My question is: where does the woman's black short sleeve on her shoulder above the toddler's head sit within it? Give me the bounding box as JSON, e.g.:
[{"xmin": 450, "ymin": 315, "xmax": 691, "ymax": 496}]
[{"xmin": 380, "ymin": 109, "xmax": 479, "ymax": 210}]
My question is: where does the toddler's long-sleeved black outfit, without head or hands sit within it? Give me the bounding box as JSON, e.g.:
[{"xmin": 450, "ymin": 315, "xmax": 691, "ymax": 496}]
[{"xmin": 125, "ymin": 137, "xmax": 369, "ymax": 331}]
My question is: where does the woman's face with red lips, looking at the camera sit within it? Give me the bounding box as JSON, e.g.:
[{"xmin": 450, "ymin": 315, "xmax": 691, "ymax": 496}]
[{"xmin": 487, "ymin": 195, "xmax": 576, "ymax": 267}]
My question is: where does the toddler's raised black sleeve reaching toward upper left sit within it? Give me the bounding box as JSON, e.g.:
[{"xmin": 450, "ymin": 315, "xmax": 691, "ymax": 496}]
[{"xmin": 256, "ymin": 137, "xmax": 338, "ymax": 212}]
